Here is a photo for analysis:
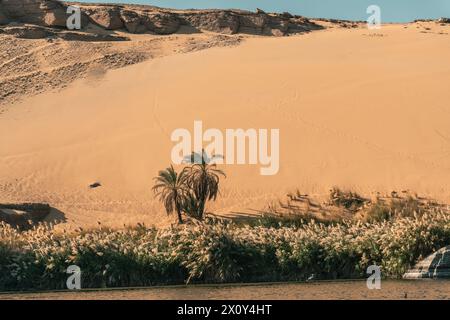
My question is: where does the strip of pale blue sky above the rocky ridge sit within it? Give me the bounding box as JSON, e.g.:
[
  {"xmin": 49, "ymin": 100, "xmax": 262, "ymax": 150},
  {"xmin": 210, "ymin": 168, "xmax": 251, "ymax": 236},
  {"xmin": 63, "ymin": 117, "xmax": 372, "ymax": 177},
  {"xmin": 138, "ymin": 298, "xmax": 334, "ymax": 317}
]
[{"xmin": 71, "ymin": 0, "xmax": 450, "ymax": 22}]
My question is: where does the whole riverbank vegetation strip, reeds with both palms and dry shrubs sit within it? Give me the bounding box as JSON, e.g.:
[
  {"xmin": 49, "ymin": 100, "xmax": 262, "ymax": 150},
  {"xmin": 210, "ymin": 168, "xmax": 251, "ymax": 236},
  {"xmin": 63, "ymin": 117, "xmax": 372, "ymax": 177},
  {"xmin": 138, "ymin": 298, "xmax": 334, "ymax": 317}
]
[{"xmin": 0, "ymin": 160, "xmax": 450, "ymax": 291}]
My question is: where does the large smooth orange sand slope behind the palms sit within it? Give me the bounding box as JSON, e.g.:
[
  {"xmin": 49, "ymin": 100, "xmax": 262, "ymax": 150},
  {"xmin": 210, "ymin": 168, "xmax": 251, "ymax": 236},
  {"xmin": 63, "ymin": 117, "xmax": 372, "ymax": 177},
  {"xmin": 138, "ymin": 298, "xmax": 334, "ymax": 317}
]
[{"xmin": 0, "ymin": 23, "xmax": 450, "ymax": 226}]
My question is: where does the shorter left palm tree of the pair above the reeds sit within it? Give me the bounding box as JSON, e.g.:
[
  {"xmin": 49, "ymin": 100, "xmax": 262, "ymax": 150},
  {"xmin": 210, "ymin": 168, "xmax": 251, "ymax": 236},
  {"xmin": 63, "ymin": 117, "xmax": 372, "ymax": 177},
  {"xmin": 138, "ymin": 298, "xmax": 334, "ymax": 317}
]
[{"xmin": 152, "ymin": 165, "xmax": 187, "ymax": 224}]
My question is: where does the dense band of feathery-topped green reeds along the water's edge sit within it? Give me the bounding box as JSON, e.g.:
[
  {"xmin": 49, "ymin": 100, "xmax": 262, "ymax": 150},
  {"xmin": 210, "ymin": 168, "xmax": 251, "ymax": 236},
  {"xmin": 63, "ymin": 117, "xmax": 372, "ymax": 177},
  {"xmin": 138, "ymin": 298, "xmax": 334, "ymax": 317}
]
[{"xmin": 0, "ymin": 204, "xmax": 450, "ymax": 291}]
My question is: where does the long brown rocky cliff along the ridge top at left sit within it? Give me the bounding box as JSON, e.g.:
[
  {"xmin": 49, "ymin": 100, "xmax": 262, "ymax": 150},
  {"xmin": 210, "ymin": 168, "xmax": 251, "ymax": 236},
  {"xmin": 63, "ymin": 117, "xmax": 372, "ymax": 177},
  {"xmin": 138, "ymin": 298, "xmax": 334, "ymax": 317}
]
[{"xmin": 0, "ymin": 0, "xmax": 320, "ymax": 36}]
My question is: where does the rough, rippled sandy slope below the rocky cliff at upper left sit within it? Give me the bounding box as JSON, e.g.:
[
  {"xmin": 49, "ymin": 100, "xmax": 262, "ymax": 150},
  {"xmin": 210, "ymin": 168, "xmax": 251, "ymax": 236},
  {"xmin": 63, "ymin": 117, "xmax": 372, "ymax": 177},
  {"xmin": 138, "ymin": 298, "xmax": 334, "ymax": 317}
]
[{"xmin": 0, "ymin": 30, "xmax": 240, "ymax": 107}]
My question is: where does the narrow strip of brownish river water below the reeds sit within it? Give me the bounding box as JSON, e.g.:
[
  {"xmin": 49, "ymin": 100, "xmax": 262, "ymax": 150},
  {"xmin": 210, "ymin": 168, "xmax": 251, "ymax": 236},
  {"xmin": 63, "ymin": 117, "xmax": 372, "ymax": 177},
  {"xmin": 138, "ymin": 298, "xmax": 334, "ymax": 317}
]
[{"xmin": 0, "ymin": 280, "xmax": 450, "ymax": 300}]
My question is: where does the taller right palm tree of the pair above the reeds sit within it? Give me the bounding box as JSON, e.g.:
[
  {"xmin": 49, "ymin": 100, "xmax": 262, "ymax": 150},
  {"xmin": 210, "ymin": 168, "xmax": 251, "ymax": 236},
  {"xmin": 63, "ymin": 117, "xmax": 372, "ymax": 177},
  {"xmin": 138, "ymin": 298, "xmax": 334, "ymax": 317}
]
[{"xmin": 183, "ymin": 150, "xmax": 225, "ymax": 220}]
